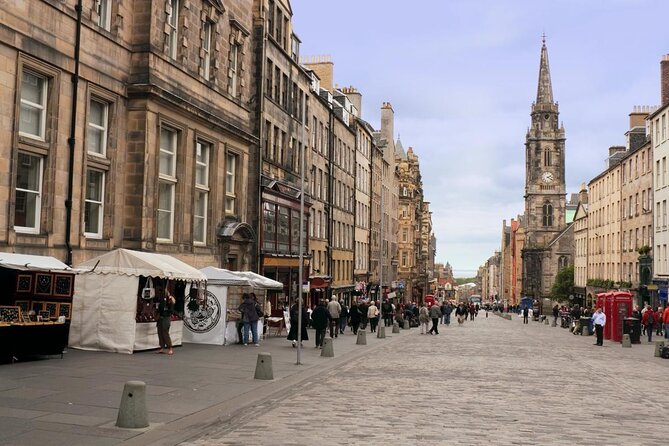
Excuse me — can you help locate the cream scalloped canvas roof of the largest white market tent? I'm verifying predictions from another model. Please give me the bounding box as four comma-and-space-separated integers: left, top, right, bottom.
77, 249, 207, 281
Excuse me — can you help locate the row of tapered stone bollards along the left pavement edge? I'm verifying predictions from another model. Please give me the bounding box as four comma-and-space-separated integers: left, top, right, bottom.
116, 321, 409, 429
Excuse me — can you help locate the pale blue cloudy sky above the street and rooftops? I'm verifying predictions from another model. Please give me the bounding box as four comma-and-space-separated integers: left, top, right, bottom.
291, 0, 669, 276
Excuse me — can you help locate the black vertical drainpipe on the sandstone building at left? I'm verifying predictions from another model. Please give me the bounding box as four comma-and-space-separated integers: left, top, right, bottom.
65, 0, 82, 266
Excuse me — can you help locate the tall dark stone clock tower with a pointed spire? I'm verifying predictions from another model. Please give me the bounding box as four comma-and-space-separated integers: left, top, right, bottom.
522, 37, 571, 298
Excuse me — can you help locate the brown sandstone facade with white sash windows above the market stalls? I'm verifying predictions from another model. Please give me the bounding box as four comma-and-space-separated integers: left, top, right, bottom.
0, 0, 257, 269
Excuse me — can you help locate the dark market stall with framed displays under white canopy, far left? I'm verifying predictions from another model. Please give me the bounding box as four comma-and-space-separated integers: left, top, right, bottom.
0, 253, 75, 361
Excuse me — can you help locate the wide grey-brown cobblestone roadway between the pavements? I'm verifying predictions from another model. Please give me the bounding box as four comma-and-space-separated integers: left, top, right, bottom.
182, 313, 669, 446
